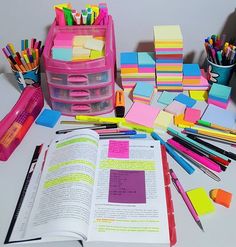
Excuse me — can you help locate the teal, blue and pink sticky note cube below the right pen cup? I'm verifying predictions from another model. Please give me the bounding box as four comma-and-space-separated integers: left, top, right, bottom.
208, 83, 231, 109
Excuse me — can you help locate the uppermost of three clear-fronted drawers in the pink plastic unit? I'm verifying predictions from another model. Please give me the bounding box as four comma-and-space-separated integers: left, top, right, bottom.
46, 70, 110, 86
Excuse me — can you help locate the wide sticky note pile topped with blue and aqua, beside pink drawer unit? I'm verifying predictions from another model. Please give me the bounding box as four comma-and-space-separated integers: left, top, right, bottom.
120, 52, 155, 90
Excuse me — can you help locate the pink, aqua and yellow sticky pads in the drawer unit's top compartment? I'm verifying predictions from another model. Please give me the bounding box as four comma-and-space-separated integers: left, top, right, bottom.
52, 32, 105, 61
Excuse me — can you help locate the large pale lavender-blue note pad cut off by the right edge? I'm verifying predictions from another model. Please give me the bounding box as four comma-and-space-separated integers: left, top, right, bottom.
201, 104, 236, 129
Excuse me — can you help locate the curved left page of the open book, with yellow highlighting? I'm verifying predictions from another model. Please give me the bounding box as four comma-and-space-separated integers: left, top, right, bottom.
26, 130, 99, 240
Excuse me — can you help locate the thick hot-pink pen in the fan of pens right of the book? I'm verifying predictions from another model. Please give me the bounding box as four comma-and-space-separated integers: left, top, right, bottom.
167, 139, 222, 172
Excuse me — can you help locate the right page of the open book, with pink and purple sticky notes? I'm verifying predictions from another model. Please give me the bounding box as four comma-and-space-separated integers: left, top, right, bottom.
84, 140, 170, 246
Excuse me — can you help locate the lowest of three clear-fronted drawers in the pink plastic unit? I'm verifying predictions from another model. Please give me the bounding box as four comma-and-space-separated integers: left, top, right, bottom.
51, 97, 114, 116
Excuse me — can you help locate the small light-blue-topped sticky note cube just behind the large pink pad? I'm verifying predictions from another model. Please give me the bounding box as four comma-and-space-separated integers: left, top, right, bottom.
133, 82, 154, 104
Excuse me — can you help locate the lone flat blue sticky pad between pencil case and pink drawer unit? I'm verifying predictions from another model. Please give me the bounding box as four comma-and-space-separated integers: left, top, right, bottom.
35, 109, 61, 128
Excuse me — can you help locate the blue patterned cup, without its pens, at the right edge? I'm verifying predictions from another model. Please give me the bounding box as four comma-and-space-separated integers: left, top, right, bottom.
207, 60, 235, 86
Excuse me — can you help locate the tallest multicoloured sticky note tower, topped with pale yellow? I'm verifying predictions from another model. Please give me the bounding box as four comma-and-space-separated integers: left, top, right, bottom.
154, 25, 183, 91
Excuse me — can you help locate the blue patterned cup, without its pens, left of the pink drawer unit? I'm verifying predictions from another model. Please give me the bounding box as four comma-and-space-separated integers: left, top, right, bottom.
12, 66, 41, 91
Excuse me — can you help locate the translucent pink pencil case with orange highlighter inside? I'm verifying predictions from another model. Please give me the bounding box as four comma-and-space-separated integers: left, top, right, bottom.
0, 86, 44, 161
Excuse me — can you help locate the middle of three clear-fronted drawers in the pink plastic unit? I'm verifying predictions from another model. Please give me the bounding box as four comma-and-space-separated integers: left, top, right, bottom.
48, 82, 114, 102
